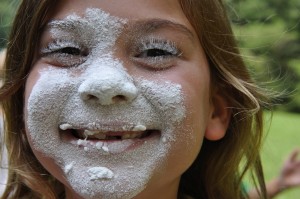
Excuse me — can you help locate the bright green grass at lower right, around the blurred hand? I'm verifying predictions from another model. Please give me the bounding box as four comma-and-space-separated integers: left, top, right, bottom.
262, 112, 300, 199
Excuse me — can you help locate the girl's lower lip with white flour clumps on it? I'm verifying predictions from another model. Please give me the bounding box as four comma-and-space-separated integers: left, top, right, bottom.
61, 132, 161, 155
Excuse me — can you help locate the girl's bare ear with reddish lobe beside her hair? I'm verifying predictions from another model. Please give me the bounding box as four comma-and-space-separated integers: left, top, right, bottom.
205, 93, 231, 141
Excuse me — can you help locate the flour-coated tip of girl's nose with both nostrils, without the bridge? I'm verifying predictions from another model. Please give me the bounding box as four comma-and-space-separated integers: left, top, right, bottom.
78, 73, 138, 105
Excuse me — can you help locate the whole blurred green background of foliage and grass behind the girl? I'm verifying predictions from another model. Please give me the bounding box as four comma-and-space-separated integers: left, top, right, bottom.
0, 0, 300, 199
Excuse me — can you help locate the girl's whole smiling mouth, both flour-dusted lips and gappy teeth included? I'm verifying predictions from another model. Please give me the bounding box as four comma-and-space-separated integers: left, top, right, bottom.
59, 123, 161, 152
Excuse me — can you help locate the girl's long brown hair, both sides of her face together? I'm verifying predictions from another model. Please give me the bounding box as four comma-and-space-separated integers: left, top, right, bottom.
0, 0, 267, 199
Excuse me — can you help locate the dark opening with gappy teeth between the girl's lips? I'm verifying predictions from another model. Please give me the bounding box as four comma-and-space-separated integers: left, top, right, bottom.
60, 124, 160, 141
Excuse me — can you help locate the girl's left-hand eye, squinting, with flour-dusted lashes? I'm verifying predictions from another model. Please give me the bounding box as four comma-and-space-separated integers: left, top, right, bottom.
41, 40, 88, 67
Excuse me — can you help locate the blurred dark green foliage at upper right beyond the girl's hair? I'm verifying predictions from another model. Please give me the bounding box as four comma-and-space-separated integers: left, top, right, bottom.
225, 0, 300, 113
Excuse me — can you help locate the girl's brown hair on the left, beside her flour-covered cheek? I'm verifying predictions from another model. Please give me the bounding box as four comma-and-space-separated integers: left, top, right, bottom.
0, 1, 61, 198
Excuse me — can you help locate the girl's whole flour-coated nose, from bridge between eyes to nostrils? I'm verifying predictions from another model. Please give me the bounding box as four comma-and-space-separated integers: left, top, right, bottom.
78, 54, 138, 105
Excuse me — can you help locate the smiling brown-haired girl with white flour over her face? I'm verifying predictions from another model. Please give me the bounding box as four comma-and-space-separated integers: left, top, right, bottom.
0, 0, 266, 199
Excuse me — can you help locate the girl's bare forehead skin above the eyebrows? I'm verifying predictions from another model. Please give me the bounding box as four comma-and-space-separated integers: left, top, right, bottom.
50, 0, 196, 35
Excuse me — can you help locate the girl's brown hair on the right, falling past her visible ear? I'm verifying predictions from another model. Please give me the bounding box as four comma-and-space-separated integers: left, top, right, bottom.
180, 0, 268, 199
